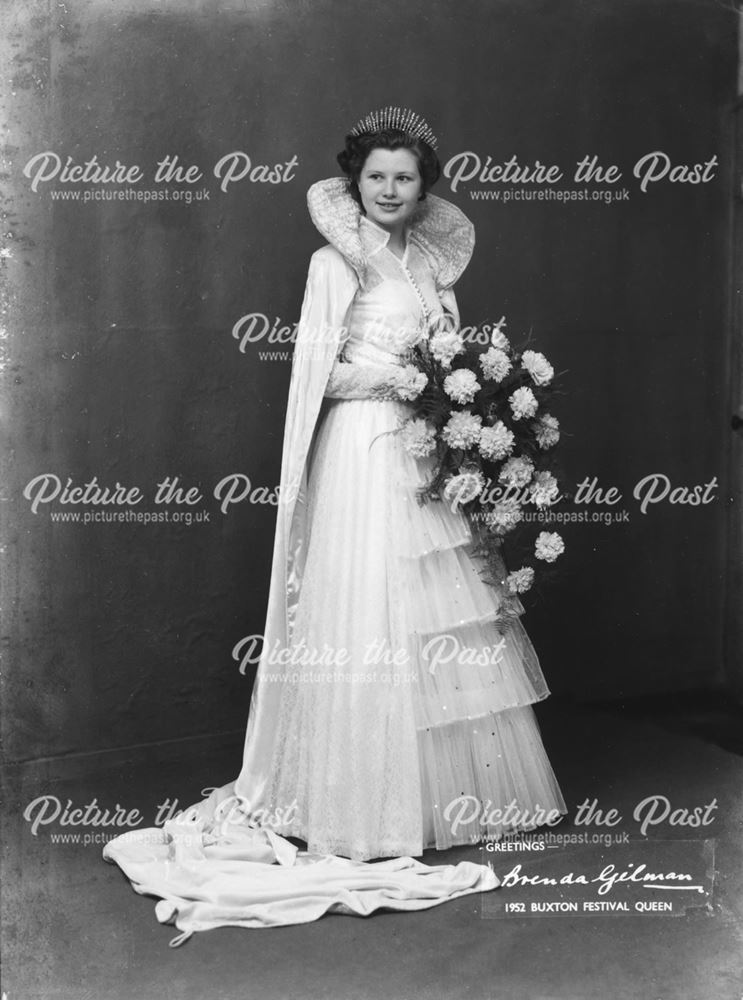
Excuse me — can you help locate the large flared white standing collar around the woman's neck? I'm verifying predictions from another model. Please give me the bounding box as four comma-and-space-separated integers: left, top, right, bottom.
307, 177, 475, 288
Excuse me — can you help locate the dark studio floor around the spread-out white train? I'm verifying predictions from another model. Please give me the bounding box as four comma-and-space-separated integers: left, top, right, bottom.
2, 698, 743, 1000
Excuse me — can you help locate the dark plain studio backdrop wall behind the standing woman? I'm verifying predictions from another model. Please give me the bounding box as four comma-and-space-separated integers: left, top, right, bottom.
3, 0, 737, 765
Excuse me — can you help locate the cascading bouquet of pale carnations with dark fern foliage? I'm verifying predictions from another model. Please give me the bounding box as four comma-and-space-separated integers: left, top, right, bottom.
400, 318, 565, 624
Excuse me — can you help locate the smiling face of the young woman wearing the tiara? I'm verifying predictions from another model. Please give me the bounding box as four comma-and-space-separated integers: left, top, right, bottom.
358, 149, 423, 231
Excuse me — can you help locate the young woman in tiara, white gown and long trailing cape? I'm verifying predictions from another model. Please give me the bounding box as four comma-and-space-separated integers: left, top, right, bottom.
105, 108, 566, 930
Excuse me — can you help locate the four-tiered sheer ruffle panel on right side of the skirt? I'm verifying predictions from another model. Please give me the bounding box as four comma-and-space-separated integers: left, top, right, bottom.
390, 402, 566, 849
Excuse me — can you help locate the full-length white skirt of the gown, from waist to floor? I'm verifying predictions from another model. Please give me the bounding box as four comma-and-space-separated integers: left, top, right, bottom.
258, 400, 566, 860
